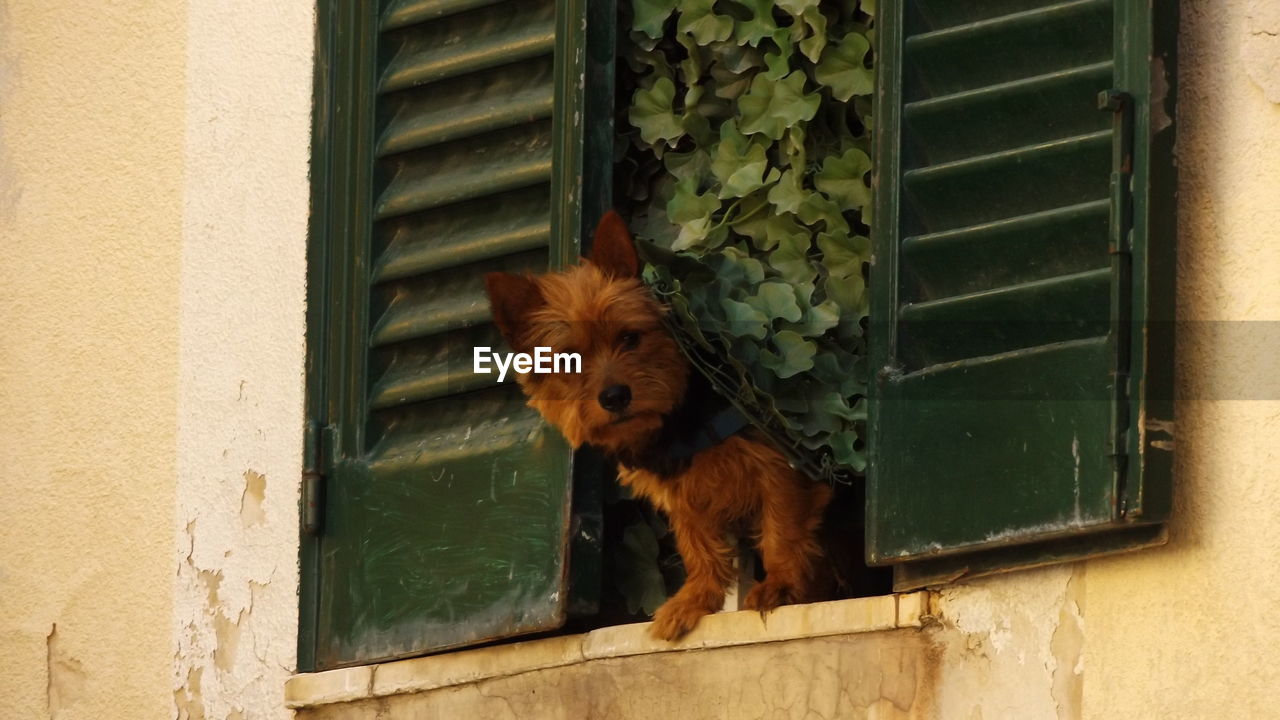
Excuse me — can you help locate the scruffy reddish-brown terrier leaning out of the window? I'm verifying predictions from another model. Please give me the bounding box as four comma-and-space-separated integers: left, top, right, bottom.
485, 211, 831, 639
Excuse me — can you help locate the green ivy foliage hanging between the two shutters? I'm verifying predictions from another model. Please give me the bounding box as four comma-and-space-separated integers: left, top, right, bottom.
617, 0, 876, 476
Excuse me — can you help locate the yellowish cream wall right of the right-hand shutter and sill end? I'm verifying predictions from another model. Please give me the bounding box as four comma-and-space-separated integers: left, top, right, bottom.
934, 0, 1280, 720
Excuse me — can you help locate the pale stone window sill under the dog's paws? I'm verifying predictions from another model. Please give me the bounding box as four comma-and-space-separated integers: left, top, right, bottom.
284, 592, 928, 708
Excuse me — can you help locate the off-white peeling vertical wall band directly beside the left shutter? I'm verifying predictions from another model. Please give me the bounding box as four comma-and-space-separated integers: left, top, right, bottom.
165, 0, 315, 720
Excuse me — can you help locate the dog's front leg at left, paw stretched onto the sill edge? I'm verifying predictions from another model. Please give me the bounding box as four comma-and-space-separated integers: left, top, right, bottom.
650, 514, 735, 641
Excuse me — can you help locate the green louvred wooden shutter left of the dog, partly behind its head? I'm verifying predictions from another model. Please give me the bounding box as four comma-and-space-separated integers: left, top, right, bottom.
300, 0, 612, 669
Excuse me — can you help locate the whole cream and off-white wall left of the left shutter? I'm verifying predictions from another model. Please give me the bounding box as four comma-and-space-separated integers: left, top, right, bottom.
0, 0, 315, 720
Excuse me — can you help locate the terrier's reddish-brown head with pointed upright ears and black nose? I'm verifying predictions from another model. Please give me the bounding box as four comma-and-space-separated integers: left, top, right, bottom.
485, 211, 689, 452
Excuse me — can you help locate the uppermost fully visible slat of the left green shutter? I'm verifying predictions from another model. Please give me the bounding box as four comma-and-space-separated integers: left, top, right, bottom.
379, 1, 556, 94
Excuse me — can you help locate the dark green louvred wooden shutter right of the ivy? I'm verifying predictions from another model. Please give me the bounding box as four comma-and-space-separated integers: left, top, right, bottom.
867, 0, 1178, 589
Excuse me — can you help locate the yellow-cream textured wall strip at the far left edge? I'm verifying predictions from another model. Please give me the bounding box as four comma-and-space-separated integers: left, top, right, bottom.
0, 0, 187, 720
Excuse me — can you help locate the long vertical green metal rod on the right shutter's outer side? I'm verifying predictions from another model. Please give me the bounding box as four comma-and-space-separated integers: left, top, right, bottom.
1098, 90, 1134, 504
